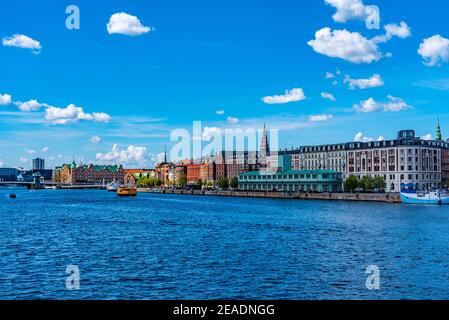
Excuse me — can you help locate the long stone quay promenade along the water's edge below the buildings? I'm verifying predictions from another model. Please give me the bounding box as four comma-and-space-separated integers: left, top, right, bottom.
139, 189, 401, 203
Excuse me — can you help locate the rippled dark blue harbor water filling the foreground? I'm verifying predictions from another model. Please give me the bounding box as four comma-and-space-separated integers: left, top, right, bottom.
0, 188, 449, 300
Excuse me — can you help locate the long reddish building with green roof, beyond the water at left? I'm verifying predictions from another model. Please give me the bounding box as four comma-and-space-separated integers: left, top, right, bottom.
58, 162, 125, 184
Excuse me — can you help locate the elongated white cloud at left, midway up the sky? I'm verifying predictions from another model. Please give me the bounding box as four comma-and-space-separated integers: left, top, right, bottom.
45, 104, 111, 124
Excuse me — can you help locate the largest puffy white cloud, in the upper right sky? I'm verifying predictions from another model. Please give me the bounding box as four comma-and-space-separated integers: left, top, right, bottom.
307, 28, 382, 64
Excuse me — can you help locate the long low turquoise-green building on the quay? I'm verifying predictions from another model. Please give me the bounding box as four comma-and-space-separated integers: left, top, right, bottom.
239, 170, 343, 193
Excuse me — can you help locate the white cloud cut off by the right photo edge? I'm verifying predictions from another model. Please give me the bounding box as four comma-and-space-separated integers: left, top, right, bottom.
418, 34, 449, 67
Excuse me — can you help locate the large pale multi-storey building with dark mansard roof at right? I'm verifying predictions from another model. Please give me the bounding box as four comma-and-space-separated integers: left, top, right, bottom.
298, 130, 449, 192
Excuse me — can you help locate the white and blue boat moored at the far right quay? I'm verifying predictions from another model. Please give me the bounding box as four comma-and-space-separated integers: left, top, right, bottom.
401, 184, 449, 205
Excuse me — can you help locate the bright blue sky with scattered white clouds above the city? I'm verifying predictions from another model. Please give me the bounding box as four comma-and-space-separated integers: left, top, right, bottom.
0, 0, 449, 167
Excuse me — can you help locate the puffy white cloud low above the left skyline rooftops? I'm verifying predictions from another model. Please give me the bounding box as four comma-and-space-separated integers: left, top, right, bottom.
96, 144, 147, 164
